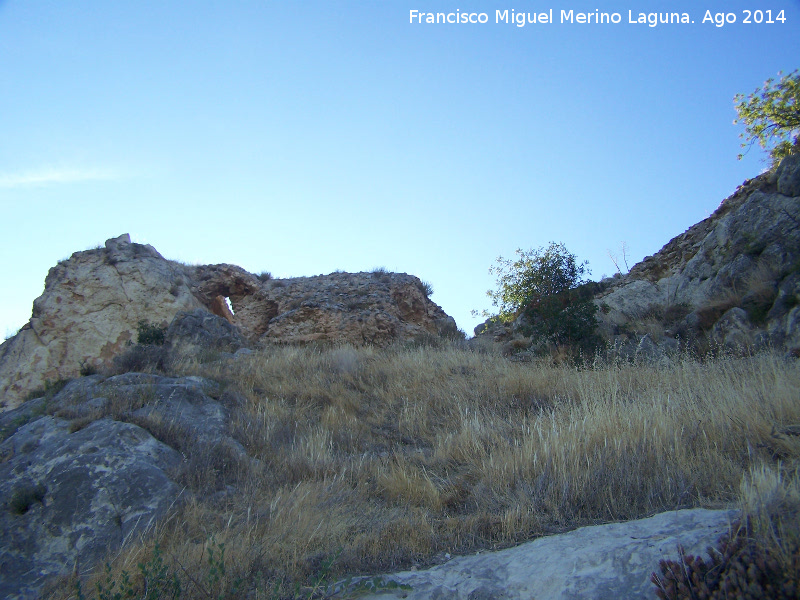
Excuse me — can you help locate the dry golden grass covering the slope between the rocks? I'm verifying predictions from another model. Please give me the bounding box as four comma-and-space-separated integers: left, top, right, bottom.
48, 347, 800, 597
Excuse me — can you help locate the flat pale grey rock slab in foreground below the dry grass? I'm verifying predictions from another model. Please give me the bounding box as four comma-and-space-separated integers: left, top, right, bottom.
363, 509, 738, 600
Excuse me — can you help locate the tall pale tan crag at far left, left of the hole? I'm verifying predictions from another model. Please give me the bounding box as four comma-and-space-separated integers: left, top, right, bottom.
0, 235, 202, 408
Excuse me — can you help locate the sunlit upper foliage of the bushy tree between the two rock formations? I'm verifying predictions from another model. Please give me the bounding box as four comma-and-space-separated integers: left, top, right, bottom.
486, 242, 588, 323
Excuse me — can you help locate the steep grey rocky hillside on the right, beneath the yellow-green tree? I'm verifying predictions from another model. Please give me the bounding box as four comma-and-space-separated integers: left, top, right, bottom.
476, 155, 800, 360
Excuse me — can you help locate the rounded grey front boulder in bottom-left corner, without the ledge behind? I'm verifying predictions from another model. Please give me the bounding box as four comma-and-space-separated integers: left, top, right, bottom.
0, 416, 181, 598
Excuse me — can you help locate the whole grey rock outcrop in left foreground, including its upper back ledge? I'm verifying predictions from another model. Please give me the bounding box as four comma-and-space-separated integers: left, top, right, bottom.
0, 373, 251, 598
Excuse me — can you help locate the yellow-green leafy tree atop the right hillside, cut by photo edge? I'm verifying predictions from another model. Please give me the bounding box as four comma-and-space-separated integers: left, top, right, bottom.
733, 69, 800, 167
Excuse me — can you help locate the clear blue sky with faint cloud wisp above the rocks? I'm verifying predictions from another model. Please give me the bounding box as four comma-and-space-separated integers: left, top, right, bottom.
0, 0, 800, 335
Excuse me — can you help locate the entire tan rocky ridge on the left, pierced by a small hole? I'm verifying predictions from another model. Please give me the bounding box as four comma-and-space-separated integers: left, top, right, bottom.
0, 234, 458, 410
